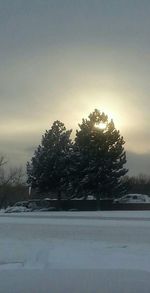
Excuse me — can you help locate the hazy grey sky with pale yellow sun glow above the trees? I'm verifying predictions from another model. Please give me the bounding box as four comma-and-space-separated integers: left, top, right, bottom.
0, 0, 150, 175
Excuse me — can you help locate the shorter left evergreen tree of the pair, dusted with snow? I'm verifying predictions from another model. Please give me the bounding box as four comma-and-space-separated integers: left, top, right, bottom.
27, 121, 72, 200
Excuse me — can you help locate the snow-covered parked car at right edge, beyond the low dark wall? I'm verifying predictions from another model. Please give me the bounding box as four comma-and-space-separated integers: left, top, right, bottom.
114, 193, 150, 203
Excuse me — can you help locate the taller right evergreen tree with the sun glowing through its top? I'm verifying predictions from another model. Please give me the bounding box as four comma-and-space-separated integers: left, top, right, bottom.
75, 110, 127, 204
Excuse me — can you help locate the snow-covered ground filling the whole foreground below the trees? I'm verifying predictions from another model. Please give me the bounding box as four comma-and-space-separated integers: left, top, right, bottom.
0, 211, 150, 293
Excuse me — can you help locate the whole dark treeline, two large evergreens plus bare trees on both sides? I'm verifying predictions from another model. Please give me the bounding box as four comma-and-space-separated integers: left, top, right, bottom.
0, 110, 150, 208
